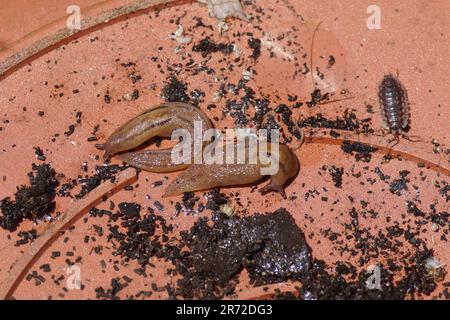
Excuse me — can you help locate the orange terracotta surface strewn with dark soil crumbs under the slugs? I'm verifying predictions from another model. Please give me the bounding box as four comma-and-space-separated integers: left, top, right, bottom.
0, 1, 450, 299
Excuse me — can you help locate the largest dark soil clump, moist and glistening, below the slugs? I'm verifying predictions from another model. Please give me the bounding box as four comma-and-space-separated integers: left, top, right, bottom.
178, 209, 311, 298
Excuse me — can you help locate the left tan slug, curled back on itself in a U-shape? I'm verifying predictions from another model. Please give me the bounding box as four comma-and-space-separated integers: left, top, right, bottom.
98, 102, 212, 172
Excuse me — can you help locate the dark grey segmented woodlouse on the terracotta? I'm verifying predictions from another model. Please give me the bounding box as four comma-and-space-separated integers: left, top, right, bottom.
378, 74, 410, 136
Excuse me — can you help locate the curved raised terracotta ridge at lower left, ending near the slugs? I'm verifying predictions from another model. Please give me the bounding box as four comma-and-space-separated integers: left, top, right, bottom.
0, 168, 137, 300
